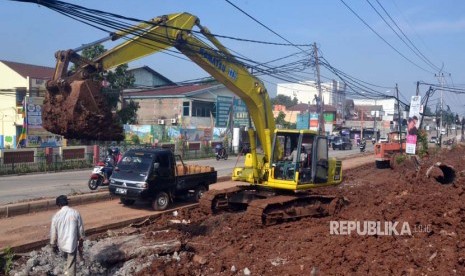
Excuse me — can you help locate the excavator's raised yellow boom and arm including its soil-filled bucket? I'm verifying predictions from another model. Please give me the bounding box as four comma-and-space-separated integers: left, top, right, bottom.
43, 13, 275, 170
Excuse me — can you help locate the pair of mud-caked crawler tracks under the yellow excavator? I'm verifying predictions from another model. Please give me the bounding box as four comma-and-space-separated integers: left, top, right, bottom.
199, 186, 348, 225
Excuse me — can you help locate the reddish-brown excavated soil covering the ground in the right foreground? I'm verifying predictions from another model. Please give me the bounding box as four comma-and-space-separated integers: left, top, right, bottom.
8, 146, 465, 275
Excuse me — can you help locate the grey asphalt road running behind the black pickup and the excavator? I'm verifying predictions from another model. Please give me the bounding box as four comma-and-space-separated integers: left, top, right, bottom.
0, 146, 373, 205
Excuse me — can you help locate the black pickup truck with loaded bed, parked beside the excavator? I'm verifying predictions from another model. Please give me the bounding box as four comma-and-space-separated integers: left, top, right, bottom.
109, 149, 217, 211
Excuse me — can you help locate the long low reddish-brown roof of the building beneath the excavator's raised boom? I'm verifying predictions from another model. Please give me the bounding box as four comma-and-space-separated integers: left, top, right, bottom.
124, 84, 222, 98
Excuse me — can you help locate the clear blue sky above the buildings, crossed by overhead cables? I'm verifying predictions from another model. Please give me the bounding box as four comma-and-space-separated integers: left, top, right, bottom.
0, 0, 465, 116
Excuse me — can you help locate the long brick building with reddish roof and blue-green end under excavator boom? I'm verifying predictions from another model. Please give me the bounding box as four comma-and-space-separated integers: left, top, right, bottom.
124, 82, 248, 128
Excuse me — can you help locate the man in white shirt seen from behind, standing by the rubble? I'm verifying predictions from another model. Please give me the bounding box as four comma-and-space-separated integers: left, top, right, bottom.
50, 195, 85, 276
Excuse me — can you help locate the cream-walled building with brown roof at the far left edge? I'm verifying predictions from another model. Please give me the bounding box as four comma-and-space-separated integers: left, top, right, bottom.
0, 60, 55, 148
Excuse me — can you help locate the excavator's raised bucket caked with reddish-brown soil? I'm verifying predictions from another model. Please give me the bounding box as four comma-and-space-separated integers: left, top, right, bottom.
42, 79, 124, 141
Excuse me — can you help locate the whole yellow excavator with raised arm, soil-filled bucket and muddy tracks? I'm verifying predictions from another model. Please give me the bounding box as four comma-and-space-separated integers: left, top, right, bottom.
42, 13, 343, 224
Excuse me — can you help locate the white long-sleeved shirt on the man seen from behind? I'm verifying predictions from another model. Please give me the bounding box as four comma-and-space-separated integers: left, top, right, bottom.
50, 206, 84, 253
